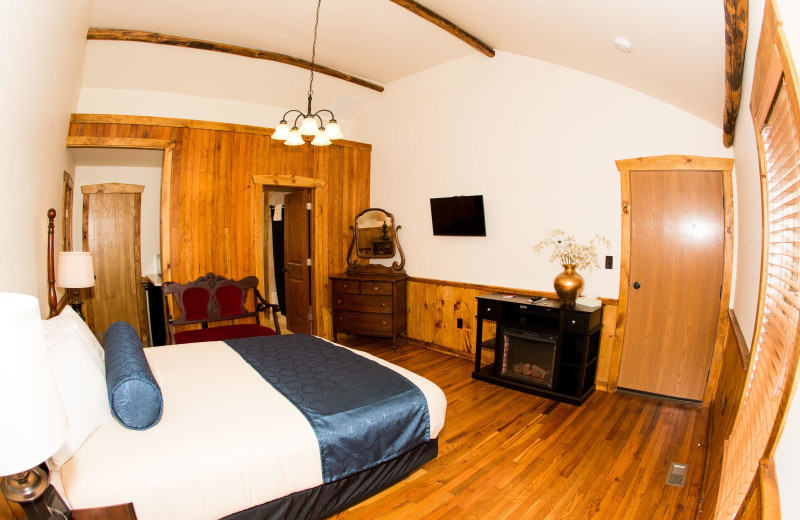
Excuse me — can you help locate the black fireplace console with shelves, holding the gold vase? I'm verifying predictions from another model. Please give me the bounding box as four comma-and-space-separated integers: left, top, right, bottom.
472, 293, 603, 405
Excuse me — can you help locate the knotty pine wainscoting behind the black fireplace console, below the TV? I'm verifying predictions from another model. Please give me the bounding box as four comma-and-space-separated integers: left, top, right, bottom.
406, 278, 619, 390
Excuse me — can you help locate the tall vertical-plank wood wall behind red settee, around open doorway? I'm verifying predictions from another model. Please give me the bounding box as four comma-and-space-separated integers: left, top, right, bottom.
68, 114, 372, 337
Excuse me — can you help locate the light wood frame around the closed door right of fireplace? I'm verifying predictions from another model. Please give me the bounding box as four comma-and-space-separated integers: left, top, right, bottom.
608, 155, 734, 407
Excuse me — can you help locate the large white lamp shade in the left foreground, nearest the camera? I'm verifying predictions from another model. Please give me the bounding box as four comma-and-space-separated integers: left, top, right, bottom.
0, 293, 69, 476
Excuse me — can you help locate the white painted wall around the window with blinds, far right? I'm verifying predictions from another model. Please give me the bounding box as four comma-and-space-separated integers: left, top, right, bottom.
732, 0, 800, 518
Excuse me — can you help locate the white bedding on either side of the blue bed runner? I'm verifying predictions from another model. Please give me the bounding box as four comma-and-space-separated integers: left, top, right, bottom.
52, 341, 447, 520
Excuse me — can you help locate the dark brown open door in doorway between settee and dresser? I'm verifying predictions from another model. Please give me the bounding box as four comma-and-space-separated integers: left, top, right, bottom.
283, 190, 311, 334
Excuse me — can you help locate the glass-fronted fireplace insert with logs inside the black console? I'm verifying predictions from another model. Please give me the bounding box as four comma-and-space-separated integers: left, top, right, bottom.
495, 328, 558, 389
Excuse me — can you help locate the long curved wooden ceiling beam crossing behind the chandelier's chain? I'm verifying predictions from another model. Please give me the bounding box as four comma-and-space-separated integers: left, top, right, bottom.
86, 28, 383, 92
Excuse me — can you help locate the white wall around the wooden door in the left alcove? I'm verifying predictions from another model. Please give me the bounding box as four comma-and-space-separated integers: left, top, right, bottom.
72, 166, 161, 275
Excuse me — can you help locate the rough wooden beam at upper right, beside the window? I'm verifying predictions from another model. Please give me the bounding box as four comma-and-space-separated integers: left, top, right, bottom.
722, 0, 749, 148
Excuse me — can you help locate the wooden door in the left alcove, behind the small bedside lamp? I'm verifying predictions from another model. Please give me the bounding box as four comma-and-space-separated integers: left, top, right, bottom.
81, 183, 149, 345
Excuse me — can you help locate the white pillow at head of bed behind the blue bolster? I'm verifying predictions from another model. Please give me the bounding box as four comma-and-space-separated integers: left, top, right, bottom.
42, 307, 111, 470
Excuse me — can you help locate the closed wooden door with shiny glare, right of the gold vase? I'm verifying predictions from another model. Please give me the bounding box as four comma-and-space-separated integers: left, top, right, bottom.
618, 170, 725, 401
